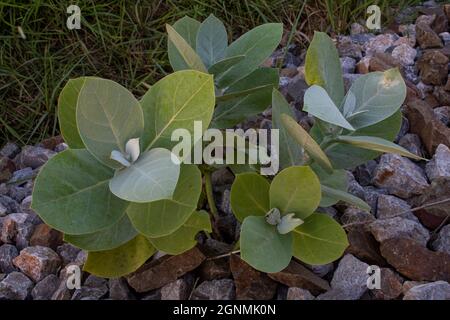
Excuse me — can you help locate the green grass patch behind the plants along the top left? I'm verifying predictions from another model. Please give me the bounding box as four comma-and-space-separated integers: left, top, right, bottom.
0, 0, 417, 146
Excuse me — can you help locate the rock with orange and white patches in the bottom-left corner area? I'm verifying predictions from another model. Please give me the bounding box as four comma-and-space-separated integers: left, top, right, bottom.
13, 246, 61, 282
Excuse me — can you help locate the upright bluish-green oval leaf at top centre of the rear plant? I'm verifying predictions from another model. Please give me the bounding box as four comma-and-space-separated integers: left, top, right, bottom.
197, 14, 228, 68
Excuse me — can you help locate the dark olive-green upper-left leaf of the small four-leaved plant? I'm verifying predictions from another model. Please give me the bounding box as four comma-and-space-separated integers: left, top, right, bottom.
230, 173, 270, 222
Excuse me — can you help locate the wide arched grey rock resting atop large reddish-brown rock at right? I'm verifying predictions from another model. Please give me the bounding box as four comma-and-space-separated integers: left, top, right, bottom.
369, 217, 430, 246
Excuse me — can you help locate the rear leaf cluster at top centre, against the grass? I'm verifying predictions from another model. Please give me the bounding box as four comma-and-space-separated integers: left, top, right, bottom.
166, 15, 283, 129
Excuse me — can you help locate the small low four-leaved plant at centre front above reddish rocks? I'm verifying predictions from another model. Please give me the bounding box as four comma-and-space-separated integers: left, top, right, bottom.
231, 166, 348, 273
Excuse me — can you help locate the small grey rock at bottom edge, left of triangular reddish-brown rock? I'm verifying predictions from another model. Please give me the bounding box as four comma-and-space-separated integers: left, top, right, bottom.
192, 279, 236, 300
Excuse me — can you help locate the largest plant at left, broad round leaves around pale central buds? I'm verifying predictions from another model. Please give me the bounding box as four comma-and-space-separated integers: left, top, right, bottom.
32, 70, 215, 277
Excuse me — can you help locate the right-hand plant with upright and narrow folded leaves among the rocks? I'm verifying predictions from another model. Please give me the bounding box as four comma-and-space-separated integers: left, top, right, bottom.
272, 32, 421, 210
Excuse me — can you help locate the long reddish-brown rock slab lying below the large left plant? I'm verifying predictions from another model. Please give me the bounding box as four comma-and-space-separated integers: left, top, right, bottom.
127, 247, 206, 292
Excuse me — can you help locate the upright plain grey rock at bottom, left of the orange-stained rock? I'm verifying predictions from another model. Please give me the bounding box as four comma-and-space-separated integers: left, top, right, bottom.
331, 254, 369, 300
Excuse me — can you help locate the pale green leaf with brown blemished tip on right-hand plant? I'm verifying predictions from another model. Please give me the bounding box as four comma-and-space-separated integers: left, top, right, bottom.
343, 69, 406, 129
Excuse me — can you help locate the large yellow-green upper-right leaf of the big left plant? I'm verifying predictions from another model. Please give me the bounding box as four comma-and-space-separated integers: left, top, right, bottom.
141, 70, 215, 150
